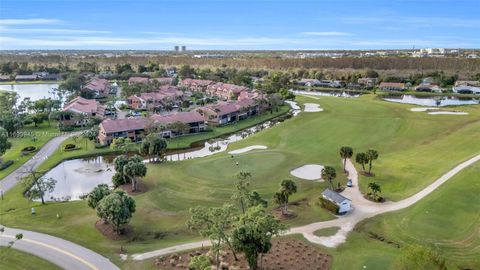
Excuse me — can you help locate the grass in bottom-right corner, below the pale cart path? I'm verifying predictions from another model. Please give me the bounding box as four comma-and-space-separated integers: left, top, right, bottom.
328, 162, 480, 269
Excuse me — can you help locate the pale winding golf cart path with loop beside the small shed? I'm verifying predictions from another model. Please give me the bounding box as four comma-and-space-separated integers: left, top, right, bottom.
132, 154, 480, 260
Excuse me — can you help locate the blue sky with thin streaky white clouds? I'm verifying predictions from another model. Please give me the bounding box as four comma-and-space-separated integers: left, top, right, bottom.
0, 0, 480, 50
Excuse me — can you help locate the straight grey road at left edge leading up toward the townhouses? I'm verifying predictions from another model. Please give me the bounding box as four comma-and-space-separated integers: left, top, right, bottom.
0, 132, 80, 192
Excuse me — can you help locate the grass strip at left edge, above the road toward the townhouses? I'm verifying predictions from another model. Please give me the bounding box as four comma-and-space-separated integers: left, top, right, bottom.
0, 122, 59, 179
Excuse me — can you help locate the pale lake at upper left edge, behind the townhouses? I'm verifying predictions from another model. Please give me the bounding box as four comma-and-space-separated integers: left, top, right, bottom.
0, 83, 58, 103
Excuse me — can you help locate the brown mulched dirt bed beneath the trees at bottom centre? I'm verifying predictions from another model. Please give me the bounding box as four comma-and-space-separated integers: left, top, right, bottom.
155, 237, 332, 270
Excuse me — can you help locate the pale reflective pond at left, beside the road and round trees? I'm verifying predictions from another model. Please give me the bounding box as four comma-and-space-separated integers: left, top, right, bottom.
37, 156, 115, 201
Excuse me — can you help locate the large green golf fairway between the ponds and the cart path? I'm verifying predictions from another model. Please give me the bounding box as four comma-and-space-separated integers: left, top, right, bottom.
0, 95, 480, 269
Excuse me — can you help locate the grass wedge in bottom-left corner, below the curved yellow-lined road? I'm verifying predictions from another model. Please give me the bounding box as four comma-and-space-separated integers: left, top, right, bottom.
0, 247, 61, 270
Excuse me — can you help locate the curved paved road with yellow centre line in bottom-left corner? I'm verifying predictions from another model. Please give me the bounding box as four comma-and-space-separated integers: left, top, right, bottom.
0, 228, 119, 270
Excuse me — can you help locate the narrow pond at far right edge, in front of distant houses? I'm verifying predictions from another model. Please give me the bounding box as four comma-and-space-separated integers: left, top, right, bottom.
384, 95, 480, 107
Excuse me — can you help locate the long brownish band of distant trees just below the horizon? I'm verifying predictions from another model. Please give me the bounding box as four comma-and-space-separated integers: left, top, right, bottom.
0, 54, 480, 76
